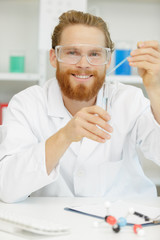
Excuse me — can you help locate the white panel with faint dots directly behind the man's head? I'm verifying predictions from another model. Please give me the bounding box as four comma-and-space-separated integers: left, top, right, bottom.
39, 0, 87, 50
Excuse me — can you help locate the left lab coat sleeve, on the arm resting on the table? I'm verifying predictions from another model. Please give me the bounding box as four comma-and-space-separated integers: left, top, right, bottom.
0, 94, 59, 203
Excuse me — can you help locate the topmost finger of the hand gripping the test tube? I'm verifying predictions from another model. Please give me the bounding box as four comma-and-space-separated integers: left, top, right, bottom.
82, 105, 111, 121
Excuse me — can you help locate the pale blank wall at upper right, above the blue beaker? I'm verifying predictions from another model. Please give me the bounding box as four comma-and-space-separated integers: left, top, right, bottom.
88, 0, 160, 42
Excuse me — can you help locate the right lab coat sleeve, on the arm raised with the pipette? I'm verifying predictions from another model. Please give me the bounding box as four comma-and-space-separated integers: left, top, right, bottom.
133, 91, 160, 165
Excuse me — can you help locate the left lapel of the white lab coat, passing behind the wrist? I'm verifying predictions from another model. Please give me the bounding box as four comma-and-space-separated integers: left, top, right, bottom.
47, 79, 79, 155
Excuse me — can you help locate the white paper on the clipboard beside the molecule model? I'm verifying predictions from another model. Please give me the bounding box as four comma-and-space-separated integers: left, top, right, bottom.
68, 201, 160, 224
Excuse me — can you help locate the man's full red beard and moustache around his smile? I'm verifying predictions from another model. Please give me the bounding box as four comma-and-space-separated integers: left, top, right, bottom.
56, 64, 106, 101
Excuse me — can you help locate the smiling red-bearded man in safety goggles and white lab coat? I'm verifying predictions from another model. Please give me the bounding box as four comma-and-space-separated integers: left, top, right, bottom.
0, 11, 160, 202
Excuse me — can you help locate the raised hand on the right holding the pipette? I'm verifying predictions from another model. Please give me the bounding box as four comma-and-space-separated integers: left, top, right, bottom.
128, 41, 160, 88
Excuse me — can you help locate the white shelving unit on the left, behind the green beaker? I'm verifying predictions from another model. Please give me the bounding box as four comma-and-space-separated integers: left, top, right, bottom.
0, 0, 40, 102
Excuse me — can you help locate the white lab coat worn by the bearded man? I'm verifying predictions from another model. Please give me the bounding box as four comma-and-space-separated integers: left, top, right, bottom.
0, 79, 160, 202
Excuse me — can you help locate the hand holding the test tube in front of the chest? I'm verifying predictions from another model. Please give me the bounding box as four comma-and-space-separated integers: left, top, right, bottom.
63, 106, 113, 143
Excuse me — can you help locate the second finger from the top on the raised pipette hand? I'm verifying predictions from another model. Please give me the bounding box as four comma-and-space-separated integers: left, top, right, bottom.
130, 48, 160, 59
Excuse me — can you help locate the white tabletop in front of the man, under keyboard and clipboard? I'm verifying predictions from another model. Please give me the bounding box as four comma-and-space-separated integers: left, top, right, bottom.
0, 197, 160, 240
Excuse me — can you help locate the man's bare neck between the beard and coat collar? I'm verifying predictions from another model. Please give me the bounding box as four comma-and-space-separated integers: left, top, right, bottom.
62, 95, 97, 116
